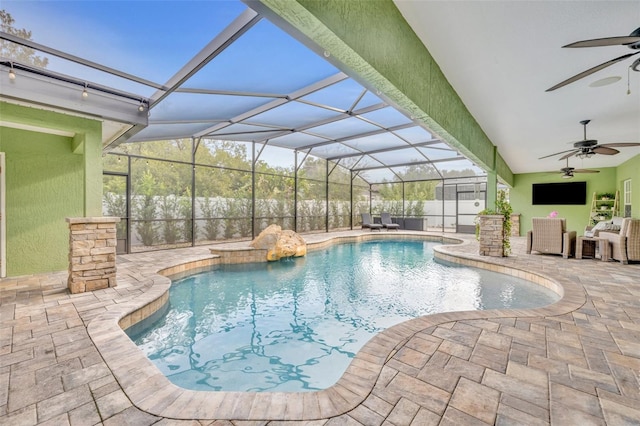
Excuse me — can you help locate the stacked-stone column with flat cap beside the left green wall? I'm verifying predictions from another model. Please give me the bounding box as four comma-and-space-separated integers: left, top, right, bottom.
67, 217, 120, 293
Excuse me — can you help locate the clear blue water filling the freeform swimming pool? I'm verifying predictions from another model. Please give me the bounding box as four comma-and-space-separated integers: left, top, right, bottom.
128, 241, 559, 391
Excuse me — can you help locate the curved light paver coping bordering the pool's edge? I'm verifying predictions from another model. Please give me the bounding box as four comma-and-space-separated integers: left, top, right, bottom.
87, 232, 586, 421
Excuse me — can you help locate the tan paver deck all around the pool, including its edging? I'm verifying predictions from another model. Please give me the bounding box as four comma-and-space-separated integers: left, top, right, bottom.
0, 231, 640, 426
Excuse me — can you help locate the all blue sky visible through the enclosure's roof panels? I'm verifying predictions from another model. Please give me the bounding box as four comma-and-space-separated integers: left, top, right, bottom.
1, 0, 484, 181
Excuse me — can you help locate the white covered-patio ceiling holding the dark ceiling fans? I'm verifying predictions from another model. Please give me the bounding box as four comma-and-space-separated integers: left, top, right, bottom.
394, 0, 640, 173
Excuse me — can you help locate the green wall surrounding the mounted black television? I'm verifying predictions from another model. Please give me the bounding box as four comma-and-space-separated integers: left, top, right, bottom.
509, 167, 616, 235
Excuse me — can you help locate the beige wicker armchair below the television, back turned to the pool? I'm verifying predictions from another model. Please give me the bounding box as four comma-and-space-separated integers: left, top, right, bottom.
527, 217, 576, 259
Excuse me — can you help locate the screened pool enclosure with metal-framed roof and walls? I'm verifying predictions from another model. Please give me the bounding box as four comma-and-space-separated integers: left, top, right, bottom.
0, 1, 486, 252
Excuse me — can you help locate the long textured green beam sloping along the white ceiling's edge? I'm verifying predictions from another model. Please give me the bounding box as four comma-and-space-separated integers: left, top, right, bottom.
252, 0, 513, 185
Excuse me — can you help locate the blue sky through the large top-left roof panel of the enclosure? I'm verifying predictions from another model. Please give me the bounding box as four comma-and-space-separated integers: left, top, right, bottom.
2, 0, 246, 83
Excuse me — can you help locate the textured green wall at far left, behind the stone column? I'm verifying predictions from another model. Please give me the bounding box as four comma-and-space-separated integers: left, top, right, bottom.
0, 102, 102, 276
